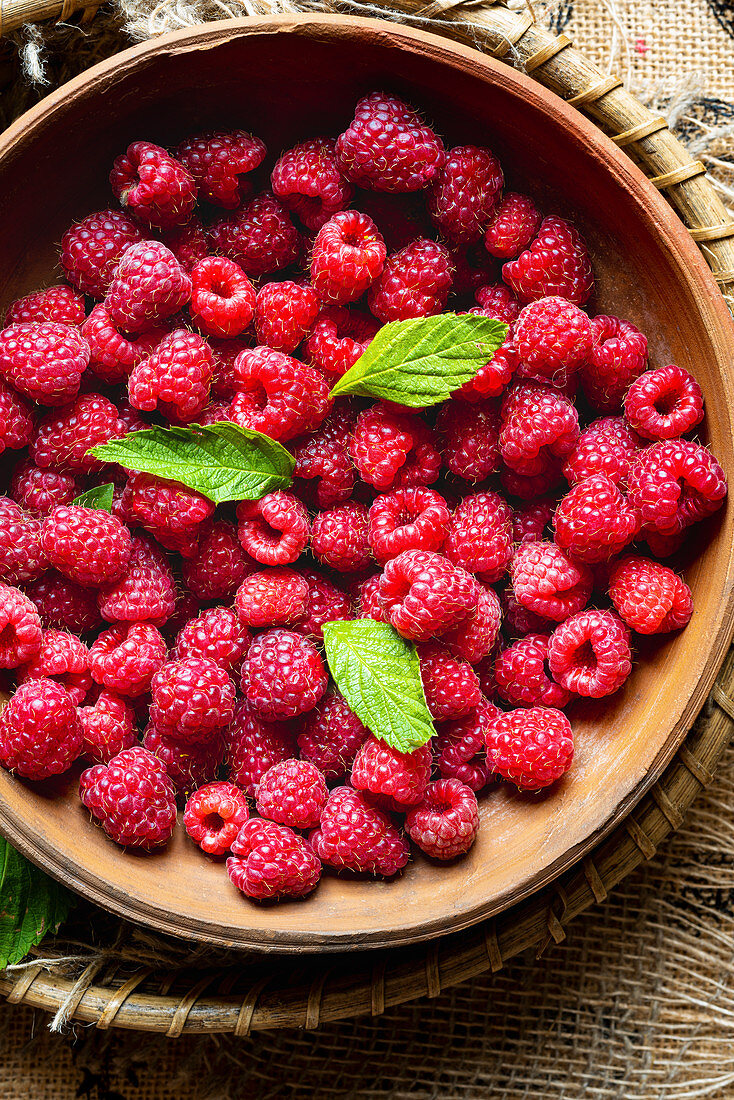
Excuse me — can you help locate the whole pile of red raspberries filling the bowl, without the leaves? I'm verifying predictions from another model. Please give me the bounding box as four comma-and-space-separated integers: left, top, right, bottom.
0, 92, 726, 899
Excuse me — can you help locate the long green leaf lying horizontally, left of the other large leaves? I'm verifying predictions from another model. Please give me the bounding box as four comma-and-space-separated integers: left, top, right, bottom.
88, 421, 295, 504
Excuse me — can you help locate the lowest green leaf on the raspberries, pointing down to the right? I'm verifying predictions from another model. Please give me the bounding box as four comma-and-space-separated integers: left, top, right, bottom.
324, 619, 436, 752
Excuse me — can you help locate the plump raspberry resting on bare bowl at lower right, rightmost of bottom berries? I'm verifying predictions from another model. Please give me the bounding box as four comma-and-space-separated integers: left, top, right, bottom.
484, 706, 573, 791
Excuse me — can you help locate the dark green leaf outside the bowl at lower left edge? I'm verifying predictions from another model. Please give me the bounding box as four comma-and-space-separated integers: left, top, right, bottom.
0, 836, 75, 969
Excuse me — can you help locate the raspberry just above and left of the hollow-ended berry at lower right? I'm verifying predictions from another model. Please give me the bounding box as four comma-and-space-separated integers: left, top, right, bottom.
510, 542, 593, 623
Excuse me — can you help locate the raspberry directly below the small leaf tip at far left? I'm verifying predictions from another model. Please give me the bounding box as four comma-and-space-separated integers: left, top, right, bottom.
41, 505, 132, 587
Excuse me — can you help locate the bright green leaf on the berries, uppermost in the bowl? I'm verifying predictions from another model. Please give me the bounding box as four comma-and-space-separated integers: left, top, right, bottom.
331, 314, 508, 408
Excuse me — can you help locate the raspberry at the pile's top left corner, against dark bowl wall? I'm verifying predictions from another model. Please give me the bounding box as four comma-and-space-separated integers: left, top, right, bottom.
110, 141, 196, 229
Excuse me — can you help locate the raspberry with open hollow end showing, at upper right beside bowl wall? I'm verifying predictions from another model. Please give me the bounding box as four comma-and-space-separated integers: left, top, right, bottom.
624, 363, 703, 439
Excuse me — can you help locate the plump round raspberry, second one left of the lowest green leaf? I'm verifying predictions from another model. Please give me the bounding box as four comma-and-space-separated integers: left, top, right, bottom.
151, 657, 234, 745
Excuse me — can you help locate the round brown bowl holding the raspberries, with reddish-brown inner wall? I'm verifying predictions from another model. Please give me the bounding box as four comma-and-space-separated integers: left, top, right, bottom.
0, 17, 734, 952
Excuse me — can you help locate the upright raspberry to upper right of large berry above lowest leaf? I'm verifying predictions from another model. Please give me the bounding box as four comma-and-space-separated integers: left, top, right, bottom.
443, 493, 513, 583
